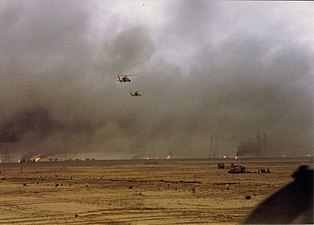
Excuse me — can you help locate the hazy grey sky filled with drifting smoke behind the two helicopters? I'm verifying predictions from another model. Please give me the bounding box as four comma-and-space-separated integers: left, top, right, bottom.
0, 0, 314, 159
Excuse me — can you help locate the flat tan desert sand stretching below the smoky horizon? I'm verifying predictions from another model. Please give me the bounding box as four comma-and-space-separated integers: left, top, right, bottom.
0, 159, 313, 225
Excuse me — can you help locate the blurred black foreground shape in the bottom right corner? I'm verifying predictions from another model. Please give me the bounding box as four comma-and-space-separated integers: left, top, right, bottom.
242, 165, 314, 224
